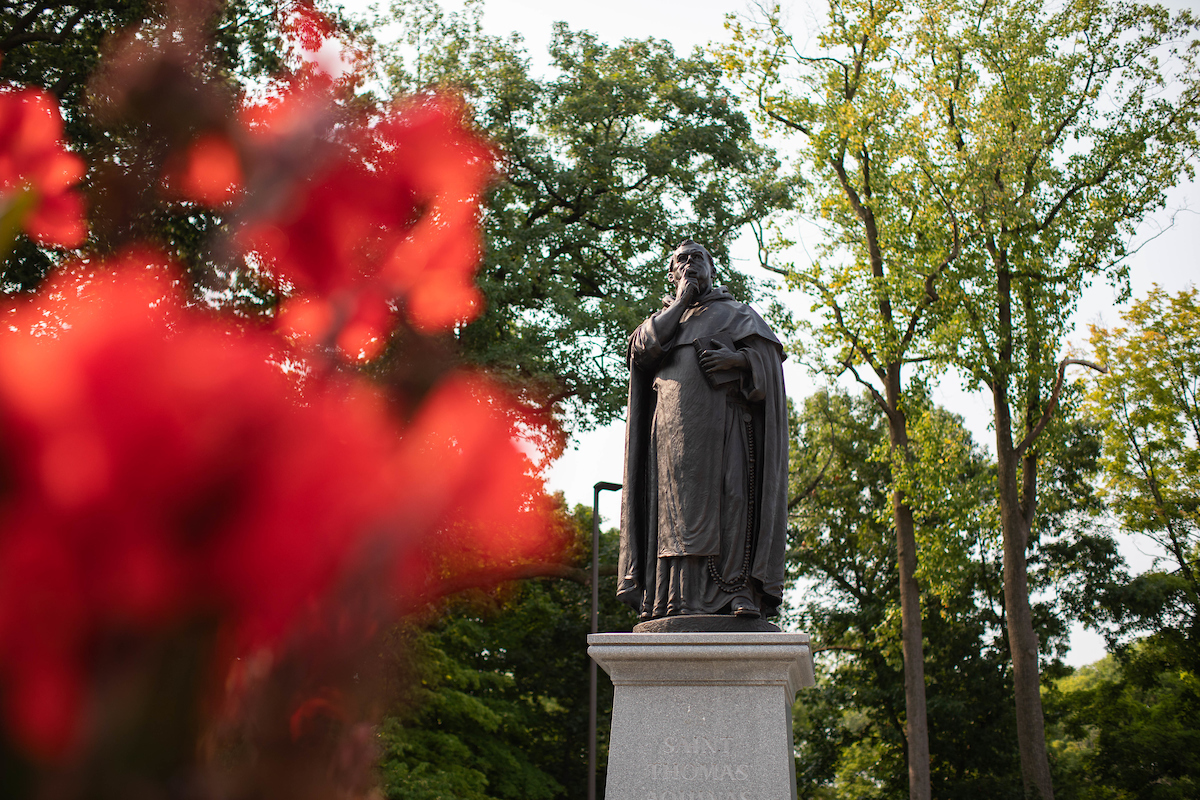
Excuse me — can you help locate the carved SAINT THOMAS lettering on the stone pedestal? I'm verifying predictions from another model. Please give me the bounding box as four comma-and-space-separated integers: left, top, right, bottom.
646, 736, 757, 800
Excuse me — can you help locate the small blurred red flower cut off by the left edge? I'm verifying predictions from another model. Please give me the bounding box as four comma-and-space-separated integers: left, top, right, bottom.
0, 89, 88, 247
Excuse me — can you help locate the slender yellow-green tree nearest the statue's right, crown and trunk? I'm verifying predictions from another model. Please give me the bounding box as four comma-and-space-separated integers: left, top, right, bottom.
721, 0, 959, 800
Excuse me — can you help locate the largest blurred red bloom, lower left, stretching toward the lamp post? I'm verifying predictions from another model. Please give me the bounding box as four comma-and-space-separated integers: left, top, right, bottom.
0, 253, 552, 757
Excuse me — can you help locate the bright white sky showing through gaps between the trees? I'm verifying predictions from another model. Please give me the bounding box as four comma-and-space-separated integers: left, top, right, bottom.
347, 0, 1200, 664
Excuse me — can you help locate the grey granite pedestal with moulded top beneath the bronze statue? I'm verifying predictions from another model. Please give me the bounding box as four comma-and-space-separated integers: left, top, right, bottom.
588, 633, 814, 800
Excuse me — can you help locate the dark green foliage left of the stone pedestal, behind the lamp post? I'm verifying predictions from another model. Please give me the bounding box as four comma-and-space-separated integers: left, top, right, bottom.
379, 506, 636, 800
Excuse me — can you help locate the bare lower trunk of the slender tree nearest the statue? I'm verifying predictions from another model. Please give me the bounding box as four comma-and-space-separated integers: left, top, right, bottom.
887, 365, 930, 800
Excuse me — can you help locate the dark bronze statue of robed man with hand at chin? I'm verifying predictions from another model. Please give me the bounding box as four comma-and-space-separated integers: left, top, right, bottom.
617, 239, 787, 621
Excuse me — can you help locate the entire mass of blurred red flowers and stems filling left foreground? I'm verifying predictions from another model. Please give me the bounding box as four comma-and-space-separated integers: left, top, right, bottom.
0, 0, 565, 796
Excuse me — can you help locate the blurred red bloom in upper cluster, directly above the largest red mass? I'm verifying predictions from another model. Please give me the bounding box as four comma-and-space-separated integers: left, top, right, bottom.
245, 94, 494, 345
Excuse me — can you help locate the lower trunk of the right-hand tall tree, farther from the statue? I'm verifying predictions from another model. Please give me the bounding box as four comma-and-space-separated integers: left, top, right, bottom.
995, 392, 1054, 800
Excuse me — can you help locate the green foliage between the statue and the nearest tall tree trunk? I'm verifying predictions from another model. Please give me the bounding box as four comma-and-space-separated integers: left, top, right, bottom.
787, 392, 905, 798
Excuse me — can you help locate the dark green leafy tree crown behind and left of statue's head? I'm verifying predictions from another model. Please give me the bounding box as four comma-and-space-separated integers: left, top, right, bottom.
369, 2, 791, 427
